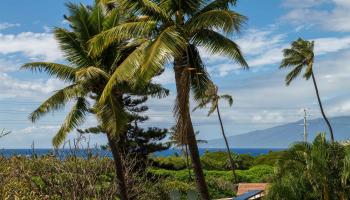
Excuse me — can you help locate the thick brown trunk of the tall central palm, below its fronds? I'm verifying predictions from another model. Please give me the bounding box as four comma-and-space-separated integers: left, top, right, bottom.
174, 65, 210, 200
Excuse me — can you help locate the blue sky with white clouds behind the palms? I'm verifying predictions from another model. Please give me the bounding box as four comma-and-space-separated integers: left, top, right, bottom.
0, 0, 350, 148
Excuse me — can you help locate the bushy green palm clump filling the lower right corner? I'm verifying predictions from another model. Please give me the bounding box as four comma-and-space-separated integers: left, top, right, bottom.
267, 134, 350, 200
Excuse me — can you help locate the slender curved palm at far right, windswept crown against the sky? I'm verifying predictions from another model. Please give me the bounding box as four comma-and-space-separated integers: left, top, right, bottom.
280, 38, 334, 142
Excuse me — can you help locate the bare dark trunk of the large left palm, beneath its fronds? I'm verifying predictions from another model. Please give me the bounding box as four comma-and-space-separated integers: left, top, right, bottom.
107, 134, 129, 200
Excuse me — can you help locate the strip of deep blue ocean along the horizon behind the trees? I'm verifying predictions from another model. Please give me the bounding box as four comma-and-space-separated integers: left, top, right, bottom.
0, 148, 283, 158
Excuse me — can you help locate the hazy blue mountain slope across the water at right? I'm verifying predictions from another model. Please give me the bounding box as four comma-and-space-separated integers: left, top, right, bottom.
200, 116, 350, 148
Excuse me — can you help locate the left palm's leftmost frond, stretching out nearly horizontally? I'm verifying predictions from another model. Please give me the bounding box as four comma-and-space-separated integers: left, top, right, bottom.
21, 62, 77, 82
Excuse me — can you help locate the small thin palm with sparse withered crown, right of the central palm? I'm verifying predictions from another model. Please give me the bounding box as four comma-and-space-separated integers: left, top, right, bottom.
193, 84, 238, 183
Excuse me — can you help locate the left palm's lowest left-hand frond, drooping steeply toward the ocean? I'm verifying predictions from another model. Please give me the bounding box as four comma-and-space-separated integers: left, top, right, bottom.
52, 97, 89, 148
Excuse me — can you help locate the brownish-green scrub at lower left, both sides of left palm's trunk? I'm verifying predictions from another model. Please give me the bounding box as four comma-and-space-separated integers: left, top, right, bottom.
0, 156, 168, 200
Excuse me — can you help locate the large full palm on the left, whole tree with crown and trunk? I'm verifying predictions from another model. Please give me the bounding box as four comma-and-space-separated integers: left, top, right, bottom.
22, 1, 164, 200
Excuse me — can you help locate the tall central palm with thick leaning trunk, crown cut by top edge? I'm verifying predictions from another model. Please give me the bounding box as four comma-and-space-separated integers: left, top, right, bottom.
90, 0, 248, 200
